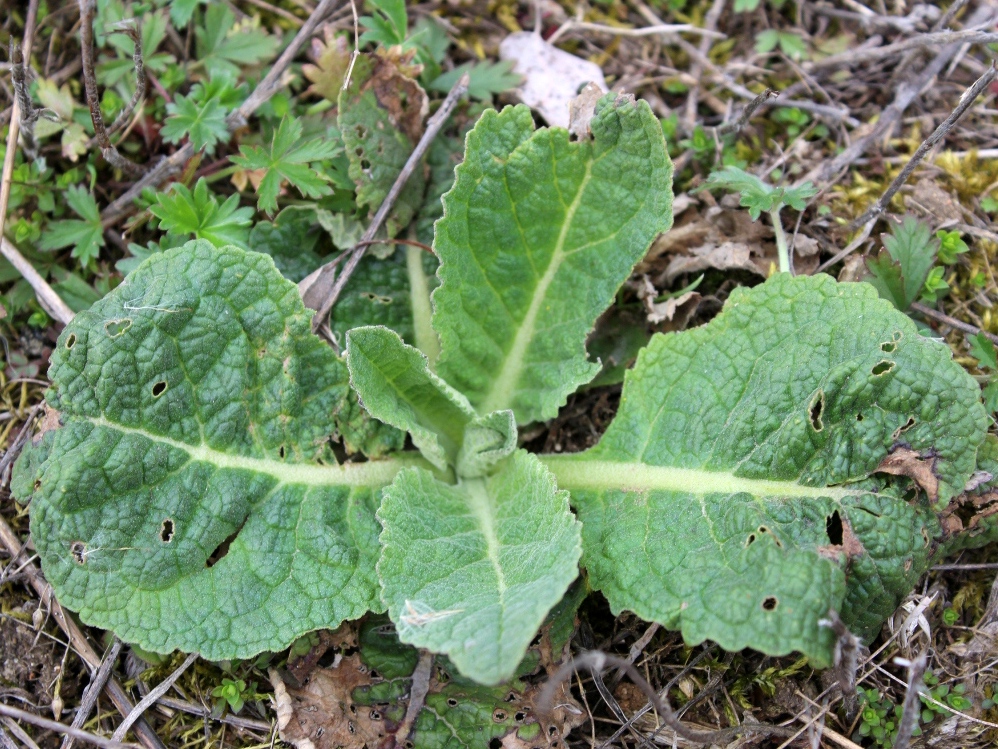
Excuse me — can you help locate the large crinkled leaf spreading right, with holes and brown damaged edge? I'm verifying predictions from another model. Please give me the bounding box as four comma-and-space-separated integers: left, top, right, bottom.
545, 274, 987, 664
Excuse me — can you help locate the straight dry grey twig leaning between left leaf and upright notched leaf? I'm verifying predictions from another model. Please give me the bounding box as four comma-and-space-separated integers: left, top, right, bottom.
299, 73, 471, 331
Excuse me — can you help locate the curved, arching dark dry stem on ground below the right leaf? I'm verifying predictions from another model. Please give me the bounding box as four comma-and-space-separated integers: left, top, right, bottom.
537, 650, 794, 745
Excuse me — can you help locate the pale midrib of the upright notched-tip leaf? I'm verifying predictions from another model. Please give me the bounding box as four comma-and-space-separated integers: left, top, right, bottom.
481, 159, 593, 413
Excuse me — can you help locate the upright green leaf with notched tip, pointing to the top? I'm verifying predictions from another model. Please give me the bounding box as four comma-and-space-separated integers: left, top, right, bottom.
433, 95, 672, 424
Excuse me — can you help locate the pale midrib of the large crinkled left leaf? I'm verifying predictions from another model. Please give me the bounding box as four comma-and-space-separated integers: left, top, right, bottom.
84, 416, 414, 488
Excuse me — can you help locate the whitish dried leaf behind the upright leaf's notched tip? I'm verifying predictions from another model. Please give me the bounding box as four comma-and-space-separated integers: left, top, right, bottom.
499, 31, 608, 132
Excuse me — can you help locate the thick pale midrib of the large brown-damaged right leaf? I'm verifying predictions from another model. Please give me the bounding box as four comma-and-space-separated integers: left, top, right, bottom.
537, 455, 868, 500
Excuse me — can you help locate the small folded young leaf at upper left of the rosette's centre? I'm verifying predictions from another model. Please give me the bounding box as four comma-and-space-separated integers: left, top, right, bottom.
347, 326, 476, 470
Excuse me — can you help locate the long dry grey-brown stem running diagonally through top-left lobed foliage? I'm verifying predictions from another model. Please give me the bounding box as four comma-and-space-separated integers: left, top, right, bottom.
101, 0, 337, 228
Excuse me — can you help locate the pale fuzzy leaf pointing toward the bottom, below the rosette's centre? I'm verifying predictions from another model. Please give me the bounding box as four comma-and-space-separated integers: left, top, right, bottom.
378, 450, 581, 684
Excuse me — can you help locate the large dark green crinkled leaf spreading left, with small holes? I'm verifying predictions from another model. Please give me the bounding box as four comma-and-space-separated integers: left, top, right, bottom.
14, 241, 414, 660
